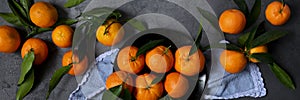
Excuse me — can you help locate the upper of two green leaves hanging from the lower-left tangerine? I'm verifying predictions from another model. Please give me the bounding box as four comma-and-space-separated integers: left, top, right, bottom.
18, 50, 35, 85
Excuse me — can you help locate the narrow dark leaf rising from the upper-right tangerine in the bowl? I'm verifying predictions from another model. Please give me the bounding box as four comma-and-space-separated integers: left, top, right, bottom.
189, 24, 202, 56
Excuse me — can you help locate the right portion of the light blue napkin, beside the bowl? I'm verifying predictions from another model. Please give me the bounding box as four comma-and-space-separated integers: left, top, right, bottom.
204, 49, 266, 99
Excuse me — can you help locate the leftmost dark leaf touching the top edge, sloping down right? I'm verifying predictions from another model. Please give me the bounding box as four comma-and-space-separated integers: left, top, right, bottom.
7, 0, 30, 26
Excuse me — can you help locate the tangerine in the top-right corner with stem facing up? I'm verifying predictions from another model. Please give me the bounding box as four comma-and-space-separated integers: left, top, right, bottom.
265, 1, 291, 26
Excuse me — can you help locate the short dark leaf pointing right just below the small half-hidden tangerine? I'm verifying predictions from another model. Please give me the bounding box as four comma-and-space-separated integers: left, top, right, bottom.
250, 53, 274, 64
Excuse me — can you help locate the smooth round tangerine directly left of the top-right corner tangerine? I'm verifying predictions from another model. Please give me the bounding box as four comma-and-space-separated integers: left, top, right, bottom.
219, 9, 246, 34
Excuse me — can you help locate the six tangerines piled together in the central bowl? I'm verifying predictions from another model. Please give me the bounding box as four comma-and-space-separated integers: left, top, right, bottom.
106, 45, 205, 100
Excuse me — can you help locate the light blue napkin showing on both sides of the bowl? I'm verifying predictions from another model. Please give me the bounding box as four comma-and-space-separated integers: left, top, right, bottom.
69, 49, 266, 100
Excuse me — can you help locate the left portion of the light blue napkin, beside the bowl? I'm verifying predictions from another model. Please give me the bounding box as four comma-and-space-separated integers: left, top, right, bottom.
69, 49, 119, 100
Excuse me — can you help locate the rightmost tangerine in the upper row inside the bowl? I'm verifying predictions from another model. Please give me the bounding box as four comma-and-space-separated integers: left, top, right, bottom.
175, 46, 205, 76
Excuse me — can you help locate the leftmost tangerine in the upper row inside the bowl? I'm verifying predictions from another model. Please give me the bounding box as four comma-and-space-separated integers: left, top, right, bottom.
117, 46, 145, 74
